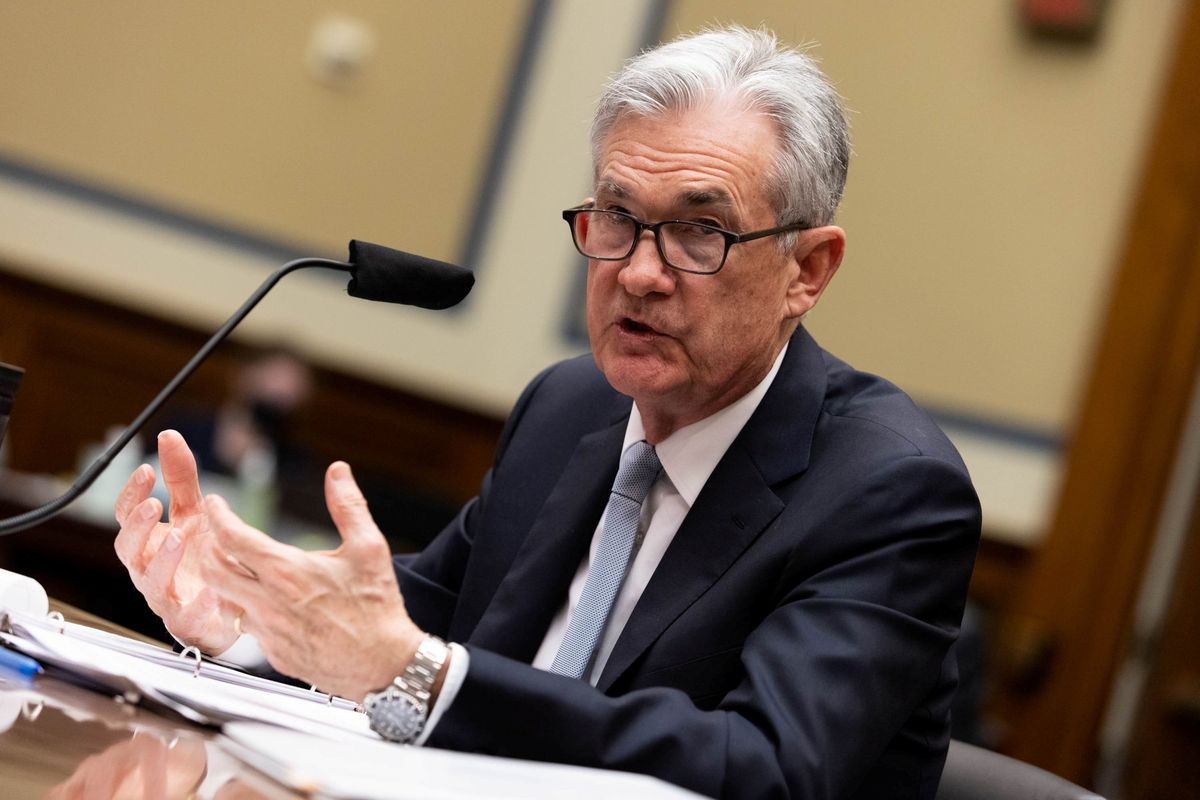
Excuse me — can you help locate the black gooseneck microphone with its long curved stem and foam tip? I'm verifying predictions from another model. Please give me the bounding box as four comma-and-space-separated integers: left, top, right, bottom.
0, 240, 475, 536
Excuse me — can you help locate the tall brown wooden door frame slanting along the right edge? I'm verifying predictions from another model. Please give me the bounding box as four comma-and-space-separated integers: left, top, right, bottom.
1001, 2, 1200, 783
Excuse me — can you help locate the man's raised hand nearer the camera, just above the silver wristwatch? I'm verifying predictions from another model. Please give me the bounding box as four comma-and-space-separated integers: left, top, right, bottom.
204, 462, 425, 700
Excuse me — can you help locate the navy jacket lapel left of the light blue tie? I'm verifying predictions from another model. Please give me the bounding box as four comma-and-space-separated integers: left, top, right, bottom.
469, 414, 628, 661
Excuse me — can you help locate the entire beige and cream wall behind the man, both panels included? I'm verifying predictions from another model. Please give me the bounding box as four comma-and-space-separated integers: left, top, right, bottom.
0, 0, 1180, 433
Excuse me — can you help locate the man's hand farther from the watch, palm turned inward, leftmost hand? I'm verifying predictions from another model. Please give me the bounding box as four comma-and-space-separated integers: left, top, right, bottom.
114, 431, 241, 654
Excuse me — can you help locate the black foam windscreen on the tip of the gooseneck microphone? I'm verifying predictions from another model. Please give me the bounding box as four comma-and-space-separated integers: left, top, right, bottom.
346, 240, 475, 309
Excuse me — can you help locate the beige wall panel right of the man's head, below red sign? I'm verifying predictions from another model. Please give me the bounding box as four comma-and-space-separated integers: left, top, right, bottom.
668, 0, 1180, 434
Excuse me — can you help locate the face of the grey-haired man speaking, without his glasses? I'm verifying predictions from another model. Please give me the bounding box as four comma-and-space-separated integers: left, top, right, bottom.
588, 104, 808, 433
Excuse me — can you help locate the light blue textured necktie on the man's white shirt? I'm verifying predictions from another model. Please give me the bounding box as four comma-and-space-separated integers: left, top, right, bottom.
550, 440, 662, 678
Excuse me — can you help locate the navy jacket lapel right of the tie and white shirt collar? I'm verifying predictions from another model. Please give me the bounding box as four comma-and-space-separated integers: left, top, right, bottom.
598, 327, 827, 690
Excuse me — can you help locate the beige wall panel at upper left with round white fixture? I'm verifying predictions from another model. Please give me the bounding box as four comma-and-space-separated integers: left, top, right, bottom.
0, 0, 527, 258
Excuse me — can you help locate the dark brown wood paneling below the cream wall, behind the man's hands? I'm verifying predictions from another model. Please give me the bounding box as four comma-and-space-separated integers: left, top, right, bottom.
0, 271, 502, 522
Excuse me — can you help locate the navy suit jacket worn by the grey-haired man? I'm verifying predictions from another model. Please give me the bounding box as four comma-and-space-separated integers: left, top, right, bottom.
396, 327, 979, 800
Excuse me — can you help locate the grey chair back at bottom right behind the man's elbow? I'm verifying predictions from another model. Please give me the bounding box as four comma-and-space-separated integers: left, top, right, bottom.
936, 740, 1104, 800
